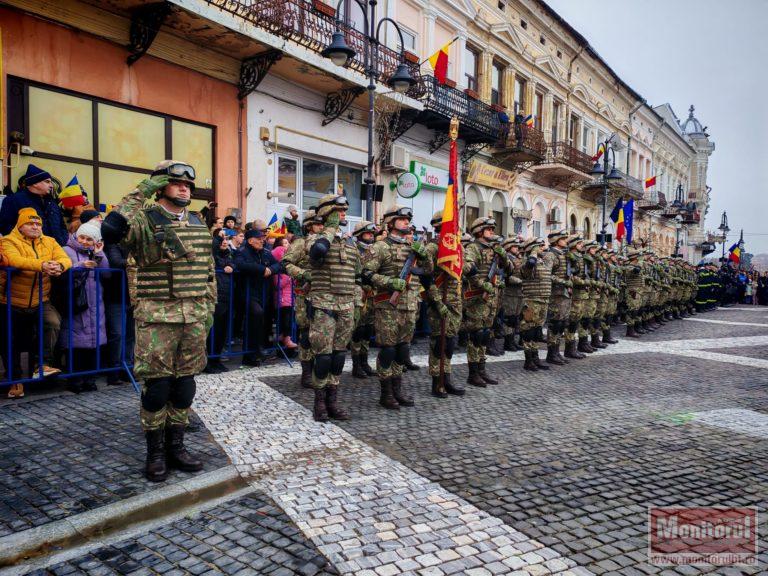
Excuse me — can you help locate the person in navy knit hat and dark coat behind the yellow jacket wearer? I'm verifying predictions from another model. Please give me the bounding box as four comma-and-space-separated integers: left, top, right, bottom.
0, 164, 69, 246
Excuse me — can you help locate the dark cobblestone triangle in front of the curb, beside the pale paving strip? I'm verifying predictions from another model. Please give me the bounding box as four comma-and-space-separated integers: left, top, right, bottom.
30, 494, 338, 576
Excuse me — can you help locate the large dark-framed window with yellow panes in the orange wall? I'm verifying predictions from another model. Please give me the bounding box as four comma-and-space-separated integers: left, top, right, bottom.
8, 77, 216, 209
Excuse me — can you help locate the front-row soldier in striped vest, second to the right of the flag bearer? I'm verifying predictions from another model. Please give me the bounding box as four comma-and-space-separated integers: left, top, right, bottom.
520, 238, 555, 372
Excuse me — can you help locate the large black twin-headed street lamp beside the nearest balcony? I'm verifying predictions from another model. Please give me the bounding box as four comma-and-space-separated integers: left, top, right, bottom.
321, 0, 416, 218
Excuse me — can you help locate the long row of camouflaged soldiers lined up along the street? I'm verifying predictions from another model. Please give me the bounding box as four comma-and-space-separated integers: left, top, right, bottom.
283, 194, 696, 421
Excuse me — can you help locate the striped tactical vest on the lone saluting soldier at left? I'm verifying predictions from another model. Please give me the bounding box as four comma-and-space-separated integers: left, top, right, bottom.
136, 207, 212, 300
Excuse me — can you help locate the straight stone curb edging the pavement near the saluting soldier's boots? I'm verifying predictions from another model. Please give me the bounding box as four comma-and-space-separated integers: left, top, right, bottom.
0, 465, 248, 569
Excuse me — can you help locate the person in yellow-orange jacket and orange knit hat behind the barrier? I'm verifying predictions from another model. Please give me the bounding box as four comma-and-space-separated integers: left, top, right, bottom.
0, 208, 72, 398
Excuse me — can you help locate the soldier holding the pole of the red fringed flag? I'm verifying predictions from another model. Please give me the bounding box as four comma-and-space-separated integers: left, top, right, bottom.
424, 210, 464, 398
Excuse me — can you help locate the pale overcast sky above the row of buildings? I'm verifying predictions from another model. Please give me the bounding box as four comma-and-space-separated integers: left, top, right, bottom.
545, 0, 768, 254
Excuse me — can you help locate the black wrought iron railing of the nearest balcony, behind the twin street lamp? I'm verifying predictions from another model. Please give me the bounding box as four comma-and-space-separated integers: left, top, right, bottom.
205, 0, 421, 98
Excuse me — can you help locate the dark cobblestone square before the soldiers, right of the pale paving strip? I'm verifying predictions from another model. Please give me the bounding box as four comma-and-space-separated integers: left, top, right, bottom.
252, 311, 768, 575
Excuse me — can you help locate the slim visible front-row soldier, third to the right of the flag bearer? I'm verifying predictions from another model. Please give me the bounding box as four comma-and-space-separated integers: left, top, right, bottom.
546, 230, 573, 366
